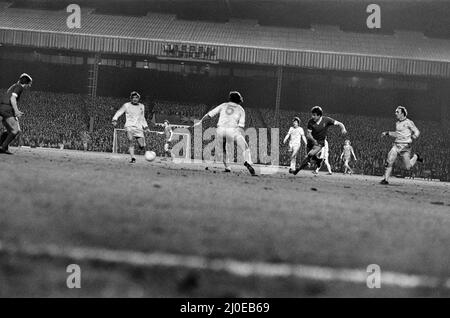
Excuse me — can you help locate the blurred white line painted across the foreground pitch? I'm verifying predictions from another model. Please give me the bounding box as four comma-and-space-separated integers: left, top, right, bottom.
0, 241, 450, 289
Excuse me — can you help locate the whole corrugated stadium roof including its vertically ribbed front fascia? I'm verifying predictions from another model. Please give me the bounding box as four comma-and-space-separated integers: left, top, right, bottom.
0, 2, 450, 77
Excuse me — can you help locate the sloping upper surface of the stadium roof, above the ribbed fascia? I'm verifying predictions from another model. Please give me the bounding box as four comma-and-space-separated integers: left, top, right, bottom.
0, 8, 450, 60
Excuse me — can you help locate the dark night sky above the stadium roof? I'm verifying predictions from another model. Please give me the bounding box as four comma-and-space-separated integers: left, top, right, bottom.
5, 0, 450, 39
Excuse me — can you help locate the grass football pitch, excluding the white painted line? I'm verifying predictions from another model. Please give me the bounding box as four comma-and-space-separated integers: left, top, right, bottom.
0, 148, 450, 297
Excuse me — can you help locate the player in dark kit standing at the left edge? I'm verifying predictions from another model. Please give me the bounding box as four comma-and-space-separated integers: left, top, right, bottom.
0, 73, 33, 155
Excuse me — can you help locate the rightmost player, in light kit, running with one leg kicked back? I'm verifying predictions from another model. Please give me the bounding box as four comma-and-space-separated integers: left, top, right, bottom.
380, 106, 423, 184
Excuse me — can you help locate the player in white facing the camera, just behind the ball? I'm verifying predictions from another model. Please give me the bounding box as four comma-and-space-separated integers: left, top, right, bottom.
112, 92, 149, 163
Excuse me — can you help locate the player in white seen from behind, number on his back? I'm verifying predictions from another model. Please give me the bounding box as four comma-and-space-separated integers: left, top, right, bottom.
194, 91, 256, 176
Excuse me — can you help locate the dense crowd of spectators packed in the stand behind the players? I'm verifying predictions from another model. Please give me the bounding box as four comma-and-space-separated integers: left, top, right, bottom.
0, 90, 450, 181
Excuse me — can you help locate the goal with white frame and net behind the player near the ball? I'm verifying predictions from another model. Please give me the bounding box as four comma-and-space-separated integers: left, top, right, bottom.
112, 128, 191, 159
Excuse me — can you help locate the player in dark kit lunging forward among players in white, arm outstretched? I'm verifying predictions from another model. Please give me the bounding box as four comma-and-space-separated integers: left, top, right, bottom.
292, 106, 347, 175
